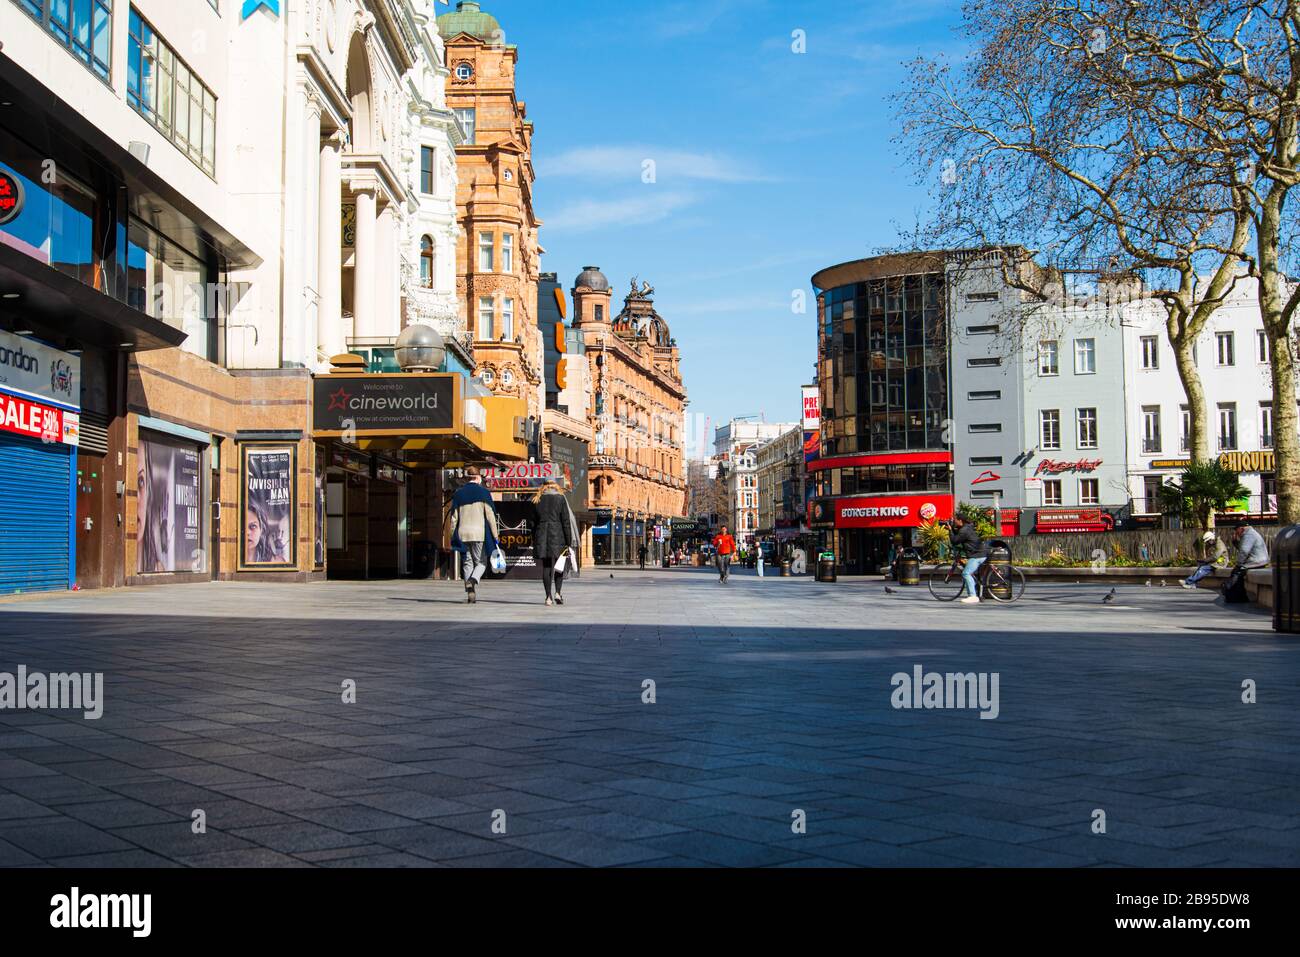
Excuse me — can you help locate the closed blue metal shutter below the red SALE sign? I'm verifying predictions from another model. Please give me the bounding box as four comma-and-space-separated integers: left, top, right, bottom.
0, 433, 73, 594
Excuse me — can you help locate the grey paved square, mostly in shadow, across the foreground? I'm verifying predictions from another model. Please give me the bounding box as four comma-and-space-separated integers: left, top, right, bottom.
0, 570, 1300, 867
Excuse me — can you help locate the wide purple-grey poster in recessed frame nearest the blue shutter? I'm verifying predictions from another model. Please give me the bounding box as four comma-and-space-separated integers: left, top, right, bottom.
135, 432, 207, 575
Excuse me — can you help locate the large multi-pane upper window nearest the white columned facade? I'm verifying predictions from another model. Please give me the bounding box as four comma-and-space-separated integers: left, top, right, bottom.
126, 7, 217, 177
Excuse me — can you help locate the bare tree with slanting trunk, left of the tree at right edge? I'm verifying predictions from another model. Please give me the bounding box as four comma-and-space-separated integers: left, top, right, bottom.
896, 0, 1251, 475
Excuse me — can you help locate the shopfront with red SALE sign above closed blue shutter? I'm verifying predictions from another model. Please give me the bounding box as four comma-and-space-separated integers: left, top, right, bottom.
0, 333, 81, 594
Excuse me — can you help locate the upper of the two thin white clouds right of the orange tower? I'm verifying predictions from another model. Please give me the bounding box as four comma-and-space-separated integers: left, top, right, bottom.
537, 146, 772, 187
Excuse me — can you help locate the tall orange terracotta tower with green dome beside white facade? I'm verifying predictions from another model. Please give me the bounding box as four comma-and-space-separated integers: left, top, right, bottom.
438, 3, 545, 421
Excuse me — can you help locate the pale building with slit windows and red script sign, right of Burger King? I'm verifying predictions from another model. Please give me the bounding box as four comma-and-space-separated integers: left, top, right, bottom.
949, 256, 1128, 524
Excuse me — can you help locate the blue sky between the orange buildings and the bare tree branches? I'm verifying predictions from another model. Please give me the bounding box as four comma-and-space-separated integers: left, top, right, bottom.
473, 0, 959, 455
